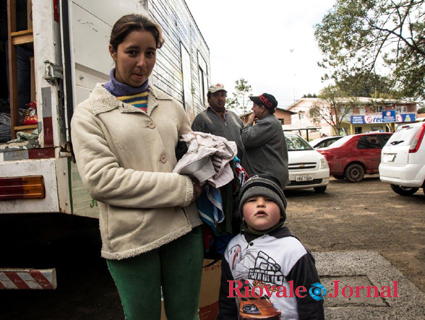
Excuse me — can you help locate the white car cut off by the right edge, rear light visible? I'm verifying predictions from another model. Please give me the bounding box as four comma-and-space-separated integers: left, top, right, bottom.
379, 122, 425, 196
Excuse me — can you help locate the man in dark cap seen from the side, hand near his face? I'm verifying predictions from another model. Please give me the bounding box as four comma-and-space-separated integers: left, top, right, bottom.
242, 93, 289, 189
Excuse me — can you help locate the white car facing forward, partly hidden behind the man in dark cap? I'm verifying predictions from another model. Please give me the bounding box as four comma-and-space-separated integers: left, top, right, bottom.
285, 132, 329, 193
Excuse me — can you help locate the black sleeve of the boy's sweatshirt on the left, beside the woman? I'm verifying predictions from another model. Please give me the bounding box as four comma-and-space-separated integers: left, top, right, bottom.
218, 258, 238, 320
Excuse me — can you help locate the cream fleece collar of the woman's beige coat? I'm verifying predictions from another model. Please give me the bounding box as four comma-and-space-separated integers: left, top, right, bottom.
89, 83, 171, 115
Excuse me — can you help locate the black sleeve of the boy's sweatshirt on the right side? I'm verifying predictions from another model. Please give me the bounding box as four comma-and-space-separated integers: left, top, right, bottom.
286, 250, 325, 320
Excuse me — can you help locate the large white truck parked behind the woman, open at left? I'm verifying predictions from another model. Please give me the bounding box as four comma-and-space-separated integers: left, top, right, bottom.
0, 0, 210, 289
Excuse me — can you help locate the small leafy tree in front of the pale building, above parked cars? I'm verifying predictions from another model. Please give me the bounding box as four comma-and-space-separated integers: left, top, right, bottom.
308, 85, 361, 134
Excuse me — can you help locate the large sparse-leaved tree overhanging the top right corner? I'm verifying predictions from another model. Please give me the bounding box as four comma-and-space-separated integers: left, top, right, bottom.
315, 0, 425, 98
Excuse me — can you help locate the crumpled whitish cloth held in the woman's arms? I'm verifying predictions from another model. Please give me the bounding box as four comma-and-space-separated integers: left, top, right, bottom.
173, 131, 238, 188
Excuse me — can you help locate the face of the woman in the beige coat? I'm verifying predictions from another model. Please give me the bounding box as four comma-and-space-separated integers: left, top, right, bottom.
109, 30, 156, 87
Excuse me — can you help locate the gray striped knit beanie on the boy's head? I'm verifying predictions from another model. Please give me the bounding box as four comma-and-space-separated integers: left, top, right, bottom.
238, 175, 287, 221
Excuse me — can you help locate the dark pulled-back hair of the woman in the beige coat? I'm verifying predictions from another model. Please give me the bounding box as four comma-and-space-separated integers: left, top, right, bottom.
109, 14, 164, 51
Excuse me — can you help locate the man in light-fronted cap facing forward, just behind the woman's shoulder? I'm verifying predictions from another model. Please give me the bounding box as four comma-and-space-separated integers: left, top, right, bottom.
192, 83, 244, 160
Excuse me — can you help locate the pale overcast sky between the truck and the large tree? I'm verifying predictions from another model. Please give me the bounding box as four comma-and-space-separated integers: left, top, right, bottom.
185, 0, 335, 108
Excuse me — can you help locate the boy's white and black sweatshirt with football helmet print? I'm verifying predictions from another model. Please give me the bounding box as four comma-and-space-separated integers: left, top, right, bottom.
219, 227, 324, 320
